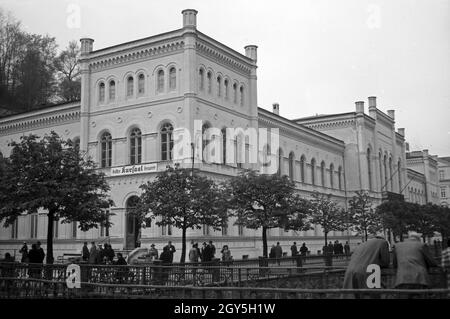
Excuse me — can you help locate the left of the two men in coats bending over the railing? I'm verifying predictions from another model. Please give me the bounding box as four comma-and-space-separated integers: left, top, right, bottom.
343, 236, 389, 289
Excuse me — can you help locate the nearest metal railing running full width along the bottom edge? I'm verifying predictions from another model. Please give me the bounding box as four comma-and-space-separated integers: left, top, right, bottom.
0, 278, 450, 299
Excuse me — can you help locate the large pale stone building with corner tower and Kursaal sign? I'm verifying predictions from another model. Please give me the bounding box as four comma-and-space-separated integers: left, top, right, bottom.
0, 10, 430, 258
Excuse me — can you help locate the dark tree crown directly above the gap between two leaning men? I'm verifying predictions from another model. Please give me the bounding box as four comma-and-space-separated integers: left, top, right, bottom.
376, 200, 412, 241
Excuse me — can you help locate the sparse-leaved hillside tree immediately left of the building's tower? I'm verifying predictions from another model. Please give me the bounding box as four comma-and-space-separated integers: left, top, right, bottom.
55, 41, 81, 102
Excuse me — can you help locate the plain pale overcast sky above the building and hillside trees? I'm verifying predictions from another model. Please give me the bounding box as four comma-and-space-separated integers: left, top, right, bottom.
0, 0, 450, 156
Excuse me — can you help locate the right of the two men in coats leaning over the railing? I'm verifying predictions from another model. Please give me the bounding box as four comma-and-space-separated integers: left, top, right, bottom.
393, 232, 437, 289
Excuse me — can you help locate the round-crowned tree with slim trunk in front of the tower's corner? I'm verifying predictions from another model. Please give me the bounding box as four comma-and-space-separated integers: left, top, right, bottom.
136, 168, 227, 263
